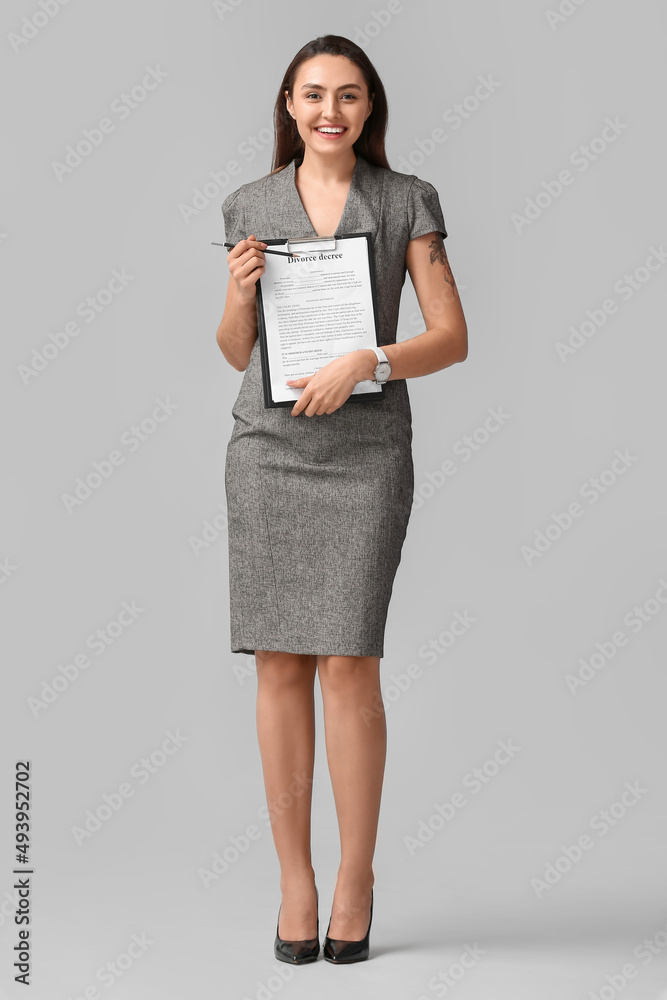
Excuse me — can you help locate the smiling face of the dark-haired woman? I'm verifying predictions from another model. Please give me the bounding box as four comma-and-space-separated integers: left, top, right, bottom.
285, 55, 373, 155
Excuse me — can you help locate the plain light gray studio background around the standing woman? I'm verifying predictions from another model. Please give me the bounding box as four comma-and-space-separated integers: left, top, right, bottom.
0, 0, 667, 1000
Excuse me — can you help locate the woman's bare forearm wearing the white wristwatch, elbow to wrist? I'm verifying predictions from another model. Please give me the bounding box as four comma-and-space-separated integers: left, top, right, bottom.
352, 323, 468, 382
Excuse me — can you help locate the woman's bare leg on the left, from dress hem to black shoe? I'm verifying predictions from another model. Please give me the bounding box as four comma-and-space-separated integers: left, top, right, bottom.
255, 649, 317, 941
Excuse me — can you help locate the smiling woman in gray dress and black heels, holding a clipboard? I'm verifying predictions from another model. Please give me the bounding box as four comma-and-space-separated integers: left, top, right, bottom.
217, 35, 467, 964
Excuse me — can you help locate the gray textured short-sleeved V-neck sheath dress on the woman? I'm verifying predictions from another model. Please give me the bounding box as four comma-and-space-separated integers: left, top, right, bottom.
222, 156, 447, 657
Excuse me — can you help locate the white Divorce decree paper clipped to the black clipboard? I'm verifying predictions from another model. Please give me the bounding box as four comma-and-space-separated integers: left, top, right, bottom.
258, 236, 382, 403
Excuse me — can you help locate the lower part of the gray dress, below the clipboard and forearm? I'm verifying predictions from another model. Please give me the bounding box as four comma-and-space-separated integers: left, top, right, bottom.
225, 341, 414, 657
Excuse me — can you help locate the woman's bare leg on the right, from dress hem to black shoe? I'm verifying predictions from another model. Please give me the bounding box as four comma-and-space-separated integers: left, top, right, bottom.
317, 656, 387, 941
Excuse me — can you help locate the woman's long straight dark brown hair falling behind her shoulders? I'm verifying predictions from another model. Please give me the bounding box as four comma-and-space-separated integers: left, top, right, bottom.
271, 35, 391, 174
